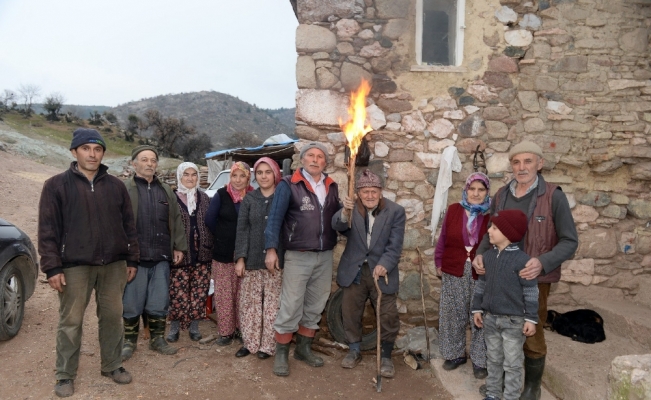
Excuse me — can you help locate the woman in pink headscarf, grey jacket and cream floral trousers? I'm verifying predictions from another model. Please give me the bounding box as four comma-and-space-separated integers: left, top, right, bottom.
235, 157, 283, 359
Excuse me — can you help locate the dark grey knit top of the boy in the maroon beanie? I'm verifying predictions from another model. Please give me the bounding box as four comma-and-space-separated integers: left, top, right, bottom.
472, 243, 538, 323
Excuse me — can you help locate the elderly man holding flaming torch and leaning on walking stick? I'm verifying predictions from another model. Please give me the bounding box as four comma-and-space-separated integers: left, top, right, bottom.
332, 169, 406, 378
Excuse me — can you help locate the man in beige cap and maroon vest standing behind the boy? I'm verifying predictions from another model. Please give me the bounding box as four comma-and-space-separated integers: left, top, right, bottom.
472, 141, 579, 400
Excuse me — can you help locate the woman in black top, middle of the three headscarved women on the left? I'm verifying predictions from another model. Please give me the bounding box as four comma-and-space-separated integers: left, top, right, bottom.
206, 161, 253, 346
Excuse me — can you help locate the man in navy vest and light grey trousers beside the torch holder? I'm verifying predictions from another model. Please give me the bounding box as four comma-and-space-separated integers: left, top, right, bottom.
264, 142, 341, 376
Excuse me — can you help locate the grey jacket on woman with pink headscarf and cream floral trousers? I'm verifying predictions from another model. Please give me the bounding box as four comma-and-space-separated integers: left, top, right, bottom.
233, 188, 284, 269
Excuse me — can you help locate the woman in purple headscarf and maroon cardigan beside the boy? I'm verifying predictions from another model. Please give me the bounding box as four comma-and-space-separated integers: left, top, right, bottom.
434, 172, 491, 379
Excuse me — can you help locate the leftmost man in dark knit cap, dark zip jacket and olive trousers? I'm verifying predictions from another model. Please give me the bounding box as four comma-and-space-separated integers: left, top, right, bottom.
38, 128, 138, 397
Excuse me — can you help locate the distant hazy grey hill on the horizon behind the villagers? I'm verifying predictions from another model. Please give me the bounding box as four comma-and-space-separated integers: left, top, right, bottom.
107, 91, 295, 150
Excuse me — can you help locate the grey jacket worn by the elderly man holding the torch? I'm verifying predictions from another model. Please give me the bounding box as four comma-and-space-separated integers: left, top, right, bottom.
332, 199, 406, 294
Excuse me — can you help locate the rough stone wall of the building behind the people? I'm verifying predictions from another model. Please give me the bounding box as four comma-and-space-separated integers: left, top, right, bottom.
296, 0, 651, 322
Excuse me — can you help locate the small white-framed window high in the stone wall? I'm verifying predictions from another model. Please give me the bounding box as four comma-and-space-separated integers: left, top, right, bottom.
416, 0, 466, 66
